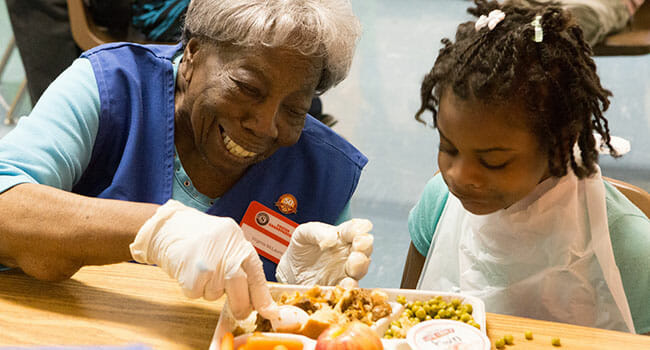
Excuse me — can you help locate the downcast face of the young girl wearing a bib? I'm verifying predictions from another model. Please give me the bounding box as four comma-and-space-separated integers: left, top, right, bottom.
437, 90, 549, 215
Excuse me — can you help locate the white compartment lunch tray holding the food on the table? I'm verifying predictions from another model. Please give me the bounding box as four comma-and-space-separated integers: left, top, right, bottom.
210, 284, 486, 350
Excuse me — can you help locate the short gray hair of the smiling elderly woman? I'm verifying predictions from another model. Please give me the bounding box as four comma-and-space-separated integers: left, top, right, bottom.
183, 0, 361, 93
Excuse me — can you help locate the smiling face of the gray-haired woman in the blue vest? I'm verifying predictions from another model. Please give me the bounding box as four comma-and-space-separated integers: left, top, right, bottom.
177, 39, 322, 178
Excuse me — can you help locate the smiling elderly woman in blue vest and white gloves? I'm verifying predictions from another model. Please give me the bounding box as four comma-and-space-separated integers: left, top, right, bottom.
0, 0, 372, 316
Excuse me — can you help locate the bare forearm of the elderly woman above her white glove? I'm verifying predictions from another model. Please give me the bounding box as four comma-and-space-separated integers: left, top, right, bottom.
0, 184, 158, 280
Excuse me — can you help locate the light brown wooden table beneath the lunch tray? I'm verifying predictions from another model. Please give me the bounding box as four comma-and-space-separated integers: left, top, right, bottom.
0, 263, 650, 350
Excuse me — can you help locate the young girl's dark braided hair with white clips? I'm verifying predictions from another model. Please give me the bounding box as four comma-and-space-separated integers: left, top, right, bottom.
415, 0, 618, 178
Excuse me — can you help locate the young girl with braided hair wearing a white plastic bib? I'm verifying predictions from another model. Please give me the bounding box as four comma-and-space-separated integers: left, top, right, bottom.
402, 0, 650, 333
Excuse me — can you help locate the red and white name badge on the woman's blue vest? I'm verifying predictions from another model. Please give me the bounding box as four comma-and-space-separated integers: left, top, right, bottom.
241, 201, 298, 264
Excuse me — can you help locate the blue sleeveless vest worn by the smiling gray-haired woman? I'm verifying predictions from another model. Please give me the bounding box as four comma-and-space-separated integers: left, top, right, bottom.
73, 43, 368, 281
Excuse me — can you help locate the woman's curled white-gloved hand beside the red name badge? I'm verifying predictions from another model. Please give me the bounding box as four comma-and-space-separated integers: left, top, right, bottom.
275, 219, 373, 287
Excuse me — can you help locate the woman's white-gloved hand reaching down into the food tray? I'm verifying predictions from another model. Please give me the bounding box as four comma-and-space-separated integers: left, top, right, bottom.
129, 200, 273, 319
